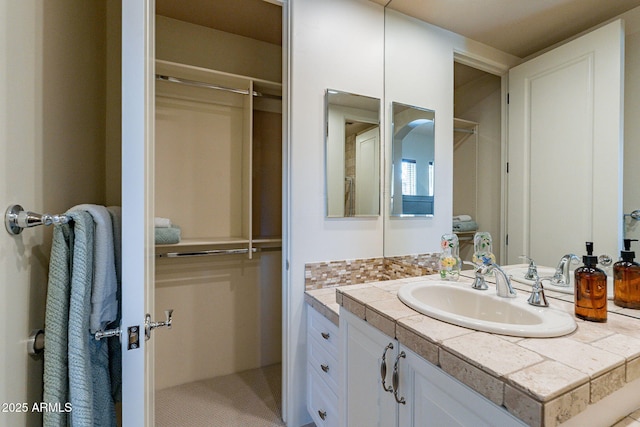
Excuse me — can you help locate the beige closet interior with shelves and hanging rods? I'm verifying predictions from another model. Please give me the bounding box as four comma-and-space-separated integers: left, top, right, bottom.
153, 0, 282, 426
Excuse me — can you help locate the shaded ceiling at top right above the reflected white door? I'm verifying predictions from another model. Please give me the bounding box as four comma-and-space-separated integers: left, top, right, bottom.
372, 0, 640, 58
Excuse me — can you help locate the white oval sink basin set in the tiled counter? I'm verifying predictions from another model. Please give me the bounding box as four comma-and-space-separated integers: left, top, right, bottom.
398, 280, 576, 338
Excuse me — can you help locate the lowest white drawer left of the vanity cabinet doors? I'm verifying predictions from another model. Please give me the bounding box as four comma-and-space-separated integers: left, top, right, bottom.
307, 366, 339, 427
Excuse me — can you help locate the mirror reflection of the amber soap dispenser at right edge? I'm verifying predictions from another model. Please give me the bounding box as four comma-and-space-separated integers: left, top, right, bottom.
613, 239, 640, 309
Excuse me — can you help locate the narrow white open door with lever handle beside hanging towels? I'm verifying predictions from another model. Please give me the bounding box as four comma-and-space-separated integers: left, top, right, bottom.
121, 0, 155, 427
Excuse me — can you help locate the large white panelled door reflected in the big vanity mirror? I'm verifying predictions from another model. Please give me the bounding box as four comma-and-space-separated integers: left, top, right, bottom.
507, 21, 624, 267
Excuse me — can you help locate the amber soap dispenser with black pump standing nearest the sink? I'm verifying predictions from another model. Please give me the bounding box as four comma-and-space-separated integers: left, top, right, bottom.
574, 242, 607, 322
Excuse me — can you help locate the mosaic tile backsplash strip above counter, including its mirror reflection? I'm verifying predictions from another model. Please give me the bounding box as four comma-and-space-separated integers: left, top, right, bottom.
304, 253, 439, 290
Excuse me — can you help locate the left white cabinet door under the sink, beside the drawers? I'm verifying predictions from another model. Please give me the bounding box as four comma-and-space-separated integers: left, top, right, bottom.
340, 310, 398, 427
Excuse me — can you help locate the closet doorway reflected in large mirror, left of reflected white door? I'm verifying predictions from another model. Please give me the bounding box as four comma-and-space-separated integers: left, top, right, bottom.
453, 62, 504, 262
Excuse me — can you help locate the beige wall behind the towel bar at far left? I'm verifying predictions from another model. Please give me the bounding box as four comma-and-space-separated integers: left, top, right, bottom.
0, 0, 106, 426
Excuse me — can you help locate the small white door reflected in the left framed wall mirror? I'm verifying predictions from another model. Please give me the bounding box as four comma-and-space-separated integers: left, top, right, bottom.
356, 126, 380, 215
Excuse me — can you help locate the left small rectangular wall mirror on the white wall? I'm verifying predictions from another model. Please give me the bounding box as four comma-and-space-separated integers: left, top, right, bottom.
325, 89, 380, 218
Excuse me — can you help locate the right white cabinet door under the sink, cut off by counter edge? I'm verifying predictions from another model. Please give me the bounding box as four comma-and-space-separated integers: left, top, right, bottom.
399, 346, 526, 427
